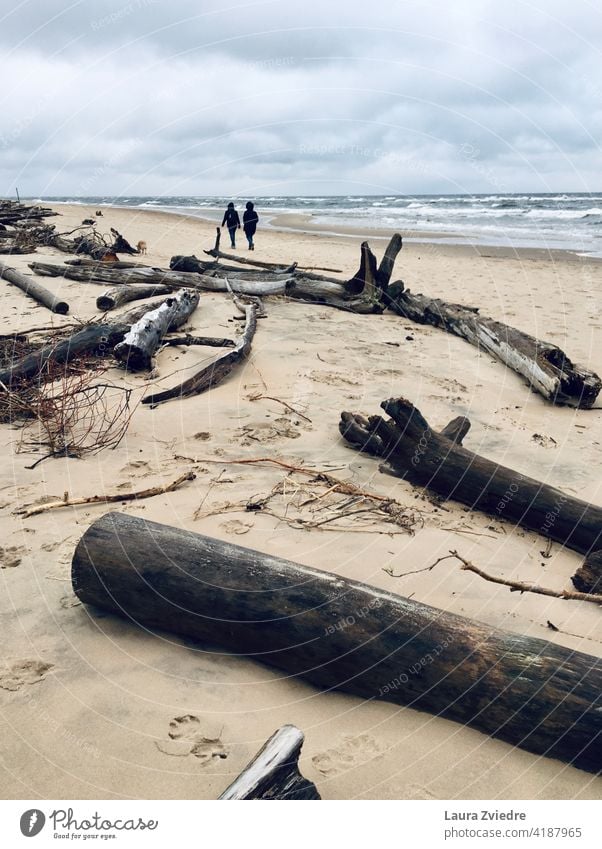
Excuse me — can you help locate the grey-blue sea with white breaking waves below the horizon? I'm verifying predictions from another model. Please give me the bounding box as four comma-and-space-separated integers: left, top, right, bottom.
37, 192, 602, 258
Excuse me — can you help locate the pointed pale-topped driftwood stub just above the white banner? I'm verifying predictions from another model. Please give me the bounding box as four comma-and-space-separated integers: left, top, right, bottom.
219, 725, 320, 800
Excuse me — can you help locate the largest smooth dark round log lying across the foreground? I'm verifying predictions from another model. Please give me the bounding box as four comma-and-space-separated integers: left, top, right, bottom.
72, 513, 602, 772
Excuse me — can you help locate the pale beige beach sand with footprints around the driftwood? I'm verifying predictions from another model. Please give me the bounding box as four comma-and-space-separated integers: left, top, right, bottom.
0, 206, 602, 799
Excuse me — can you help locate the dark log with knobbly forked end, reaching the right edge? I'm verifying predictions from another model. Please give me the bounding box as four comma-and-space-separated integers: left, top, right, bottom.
339, 398, 602, 553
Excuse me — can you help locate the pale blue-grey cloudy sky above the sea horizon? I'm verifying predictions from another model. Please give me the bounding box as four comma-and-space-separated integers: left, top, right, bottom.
0, 0, 602, 197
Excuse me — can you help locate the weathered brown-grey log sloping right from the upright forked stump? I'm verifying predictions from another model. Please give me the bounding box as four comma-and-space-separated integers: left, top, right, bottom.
387, 281, 602, 409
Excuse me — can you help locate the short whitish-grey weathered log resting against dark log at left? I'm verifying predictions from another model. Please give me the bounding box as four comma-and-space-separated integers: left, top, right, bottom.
113, 289, 199, 371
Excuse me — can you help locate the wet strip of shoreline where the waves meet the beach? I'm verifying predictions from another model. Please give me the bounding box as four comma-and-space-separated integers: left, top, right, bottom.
36, 199, 602, 264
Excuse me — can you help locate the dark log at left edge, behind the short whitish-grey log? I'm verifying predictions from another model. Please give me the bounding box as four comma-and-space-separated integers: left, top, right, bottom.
0, 304, 171, 386
